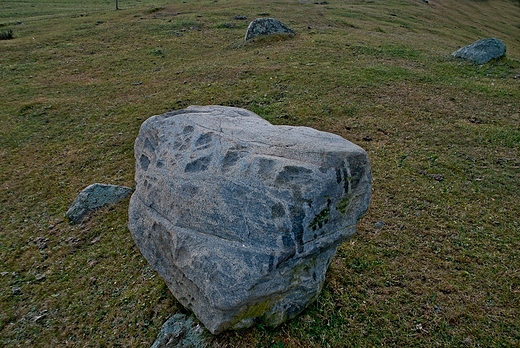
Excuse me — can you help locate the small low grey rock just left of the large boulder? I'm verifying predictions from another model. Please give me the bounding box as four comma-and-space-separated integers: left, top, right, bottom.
65, 184, 132, 224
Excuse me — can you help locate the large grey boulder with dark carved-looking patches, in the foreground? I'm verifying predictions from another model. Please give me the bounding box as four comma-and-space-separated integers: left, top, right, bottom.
129, 106, 371, 334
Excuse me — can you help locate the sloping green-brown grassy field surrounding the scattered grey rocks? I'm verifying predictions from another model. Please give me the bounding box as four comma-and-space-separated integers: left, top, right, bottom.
0, 0, 520, 347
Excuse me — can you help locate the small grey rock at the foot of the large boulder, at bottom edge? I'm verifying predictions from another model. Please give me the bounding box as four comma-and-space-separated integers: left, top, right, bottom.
151, 314, 207, 348
